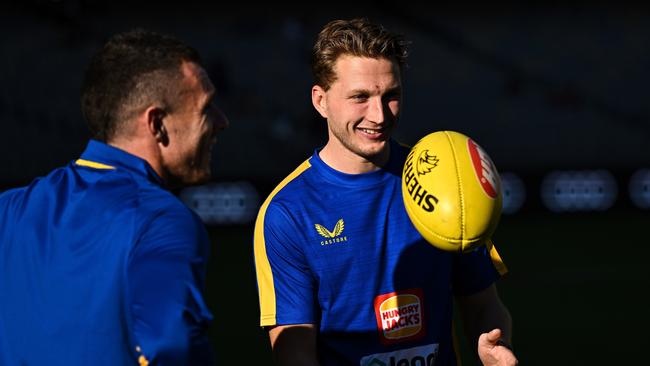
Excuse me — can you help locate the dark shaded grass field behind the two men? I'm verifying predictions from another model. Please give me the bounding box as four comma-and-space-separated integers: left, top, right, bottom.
207, 212, 650, 365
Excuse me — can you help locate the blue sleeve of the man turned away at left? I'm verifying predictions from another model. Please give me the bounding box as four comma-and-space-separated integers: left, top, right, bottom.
127, 205, 213, 365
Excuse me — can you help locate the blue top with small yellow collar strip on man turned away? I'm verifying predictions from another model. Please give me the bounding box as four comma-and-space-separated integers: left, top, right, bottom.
0, 141, 212, 366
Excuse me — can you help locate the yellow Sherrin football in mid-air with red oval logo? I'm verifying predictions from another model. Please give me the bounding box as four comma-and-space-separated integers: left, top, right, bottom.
402, 131, 502, 252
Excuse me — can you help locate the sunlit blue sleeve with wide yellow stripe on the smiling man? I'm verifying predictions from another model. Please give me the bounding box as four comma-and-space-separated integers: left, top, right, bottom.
254, 203, 317, 326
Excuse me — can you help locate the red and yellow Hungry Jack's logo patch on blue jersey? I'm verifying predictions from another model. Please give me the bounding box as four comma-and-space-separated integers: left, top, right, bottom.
374, 288, 426, 345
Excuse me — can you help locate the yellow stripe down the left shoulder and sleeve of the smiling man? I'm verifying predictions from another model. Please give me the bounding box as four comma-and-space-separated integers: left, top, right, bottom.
253, 160, 311, 327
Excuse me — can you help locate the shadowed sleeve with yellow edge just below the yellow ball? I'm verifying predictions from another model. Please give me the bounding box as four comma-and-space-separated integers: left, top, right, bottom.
452, 240, 507, 296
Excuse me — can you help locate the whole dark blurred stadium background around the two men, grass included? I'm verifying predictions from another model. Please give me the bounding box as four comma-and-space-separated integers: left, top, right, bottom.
0, 0, 650, 365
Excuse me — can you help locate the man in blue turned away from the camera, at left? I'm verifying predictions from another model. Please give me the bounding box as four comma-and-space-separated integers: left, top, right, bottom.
0, 30, 228, 366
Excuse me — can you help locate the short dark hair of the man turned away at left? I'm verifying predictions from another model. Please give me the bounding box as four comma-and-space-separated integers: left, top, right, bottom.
81, 29, 200, 142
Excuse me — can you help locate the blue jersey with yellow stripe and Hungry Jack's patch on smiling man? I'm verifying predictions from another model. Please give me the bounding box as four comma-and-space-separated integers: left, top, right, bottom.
254, 141, 505, 365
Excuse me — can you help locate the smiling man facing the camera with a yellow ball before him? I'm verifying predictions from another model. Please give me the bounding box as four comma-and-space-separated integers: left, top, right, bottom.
254, 19, 517, 366
